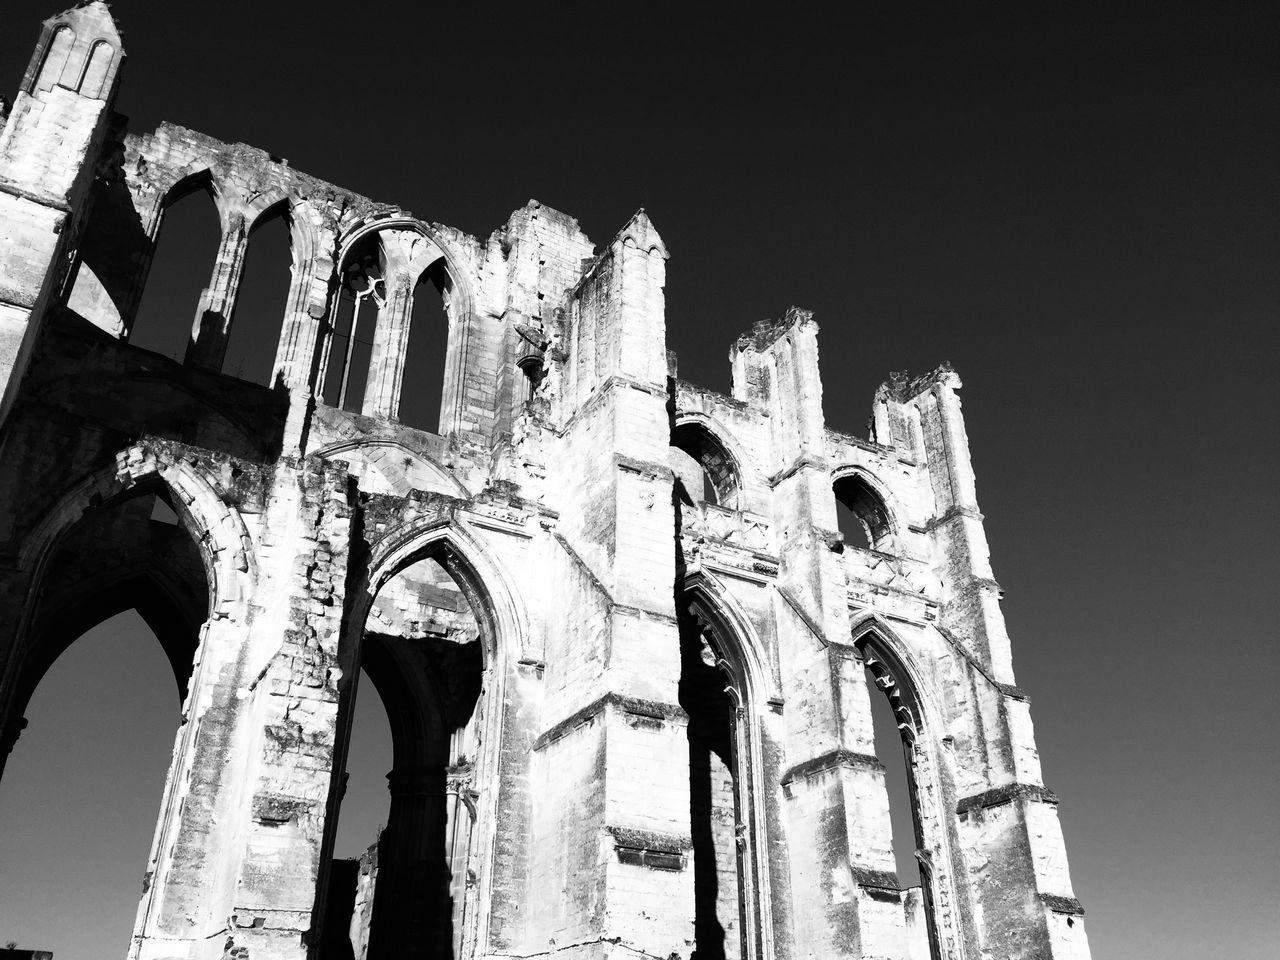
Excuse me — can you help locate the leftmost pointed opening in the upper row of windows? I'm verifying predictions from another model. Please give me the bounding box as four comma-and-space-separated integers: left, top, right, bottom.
129, 180, 221, 362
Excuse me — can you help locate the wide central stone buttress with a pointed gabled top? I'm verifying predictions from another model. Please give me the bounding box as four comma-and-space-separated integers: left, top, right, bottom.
513, 211, 694, 957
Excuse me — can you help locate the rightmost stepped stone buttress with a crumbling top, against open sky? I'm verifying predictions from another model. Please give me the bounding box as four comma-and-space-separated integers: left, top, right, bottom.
890, 366, 1088, 960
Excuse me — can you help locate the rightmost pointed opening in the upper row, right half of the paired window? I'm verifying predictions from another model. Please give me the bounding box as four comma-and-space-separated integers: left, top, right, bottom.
399, 259, 453, 433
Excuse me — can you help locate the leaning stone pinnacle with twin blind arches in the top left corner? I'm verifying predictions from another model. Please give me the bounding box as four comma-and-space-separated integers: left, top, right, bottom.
0, 3, 124, 422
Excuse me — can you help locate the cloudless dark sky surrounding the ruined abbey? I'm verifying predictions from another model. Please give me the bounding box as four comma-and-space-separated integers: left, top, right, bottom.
0, 0, 1280, 960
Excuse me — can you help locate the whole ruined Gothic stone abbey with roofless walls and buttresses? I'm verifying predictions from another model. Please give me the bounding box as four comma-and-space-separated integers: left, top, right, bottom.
0, 3, 1089, 960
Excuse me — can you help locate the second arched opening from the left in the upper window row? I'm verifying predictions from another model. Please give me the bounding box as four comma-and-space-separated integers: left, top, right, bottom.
223, 205, 293, 387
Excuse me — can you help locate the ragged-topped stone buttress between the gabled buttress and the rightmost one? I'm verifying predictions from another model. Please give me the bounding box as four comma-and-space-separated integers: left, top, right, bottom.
732, 307, 906, 957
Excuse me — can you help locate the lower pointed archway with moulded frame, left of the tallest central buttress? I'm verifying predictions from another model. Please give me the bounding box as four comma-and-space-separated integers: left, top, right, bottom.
314, 522, 511, 960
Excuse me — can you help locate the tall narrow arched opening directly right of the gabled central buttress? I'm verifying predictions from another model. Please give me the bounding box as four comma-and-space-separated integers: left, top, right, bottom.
680, 596, 758, 960
